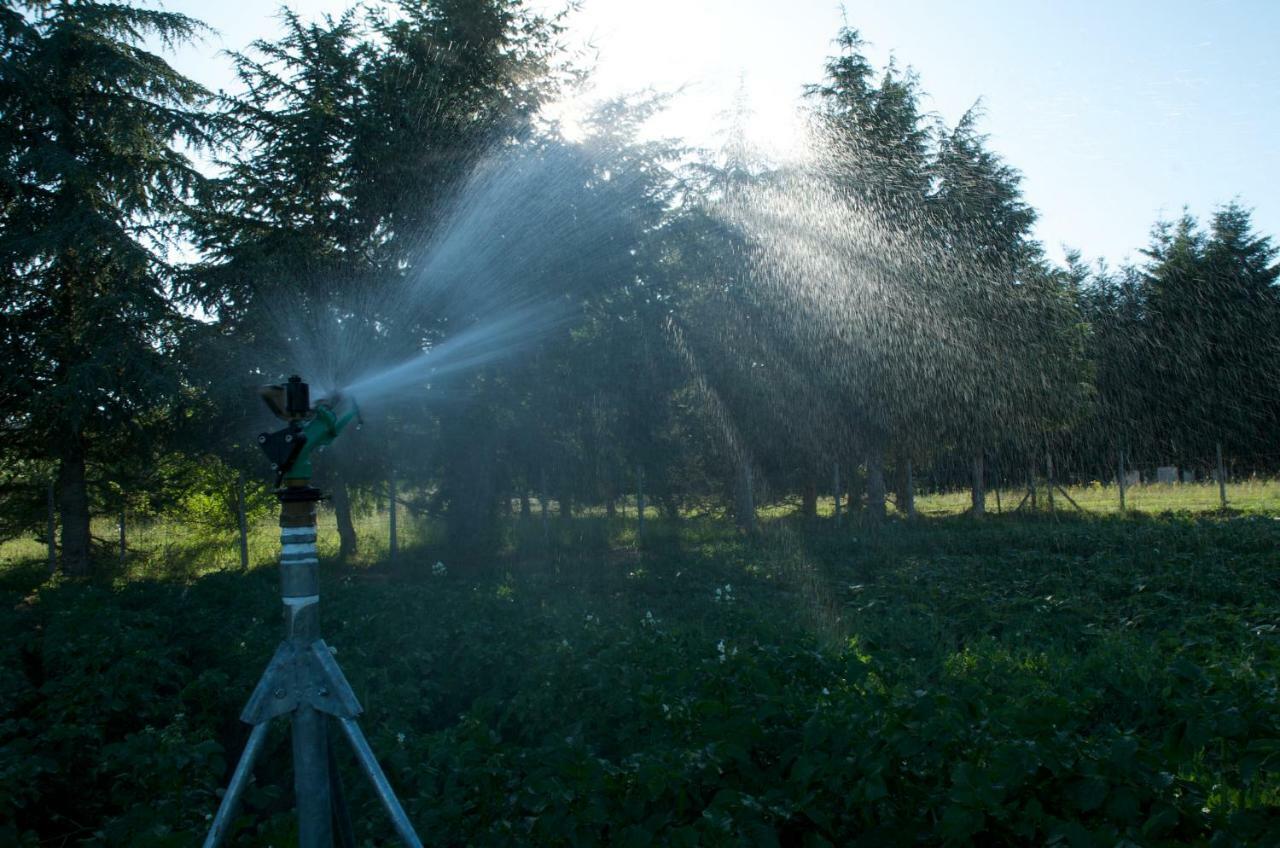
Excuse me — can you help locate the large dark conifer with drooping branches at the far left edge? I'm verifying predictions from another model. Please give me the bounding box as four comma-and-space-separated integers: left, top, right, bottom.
0, 0, 214, 574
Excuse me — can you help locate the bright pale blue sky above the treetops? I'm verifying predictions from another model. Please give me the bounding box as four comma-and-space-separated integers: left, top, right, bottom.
154, 0, 1280, 264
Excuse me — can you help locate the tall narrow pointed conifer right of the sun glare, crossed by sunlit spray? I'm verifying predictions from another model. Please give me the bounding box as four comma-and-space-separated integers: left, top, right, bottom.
805, 27, 941, 515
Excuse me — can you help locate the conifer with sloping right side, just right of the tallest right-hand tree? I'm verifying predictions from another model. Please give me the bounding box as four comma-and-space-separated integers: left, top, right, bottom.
928, 109, 1084, 479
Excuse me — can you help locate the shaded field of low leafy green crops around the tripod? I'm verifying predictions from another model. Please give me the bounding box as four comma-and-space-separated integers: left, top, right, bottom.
0, 489, 1280, 845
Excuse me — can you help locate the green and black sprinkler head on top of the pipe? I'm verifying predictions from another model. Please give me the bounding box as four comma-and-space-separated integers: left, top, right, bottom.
257, 375, 360, 487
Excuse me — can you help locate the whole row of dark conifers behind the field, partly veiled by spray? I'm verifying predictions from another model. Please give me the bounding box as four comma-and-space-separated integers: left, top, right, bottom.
0, 0, 1280, 574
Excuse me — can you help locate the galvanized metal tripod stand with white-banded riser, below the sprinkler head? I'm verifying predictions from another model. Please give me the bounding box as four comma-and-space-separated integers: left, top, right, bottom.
205, 478, 422, 848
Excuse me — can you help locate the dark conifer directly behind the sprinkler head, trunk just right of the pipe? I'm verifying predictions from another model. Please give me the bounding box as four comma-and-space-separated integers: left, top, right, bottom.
183, 10, 373, 557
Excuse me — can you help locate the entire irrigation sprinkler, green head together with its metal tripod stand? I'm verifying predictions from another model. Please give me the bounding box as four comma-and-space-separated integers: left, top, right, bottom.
205, 377, 422, 848
